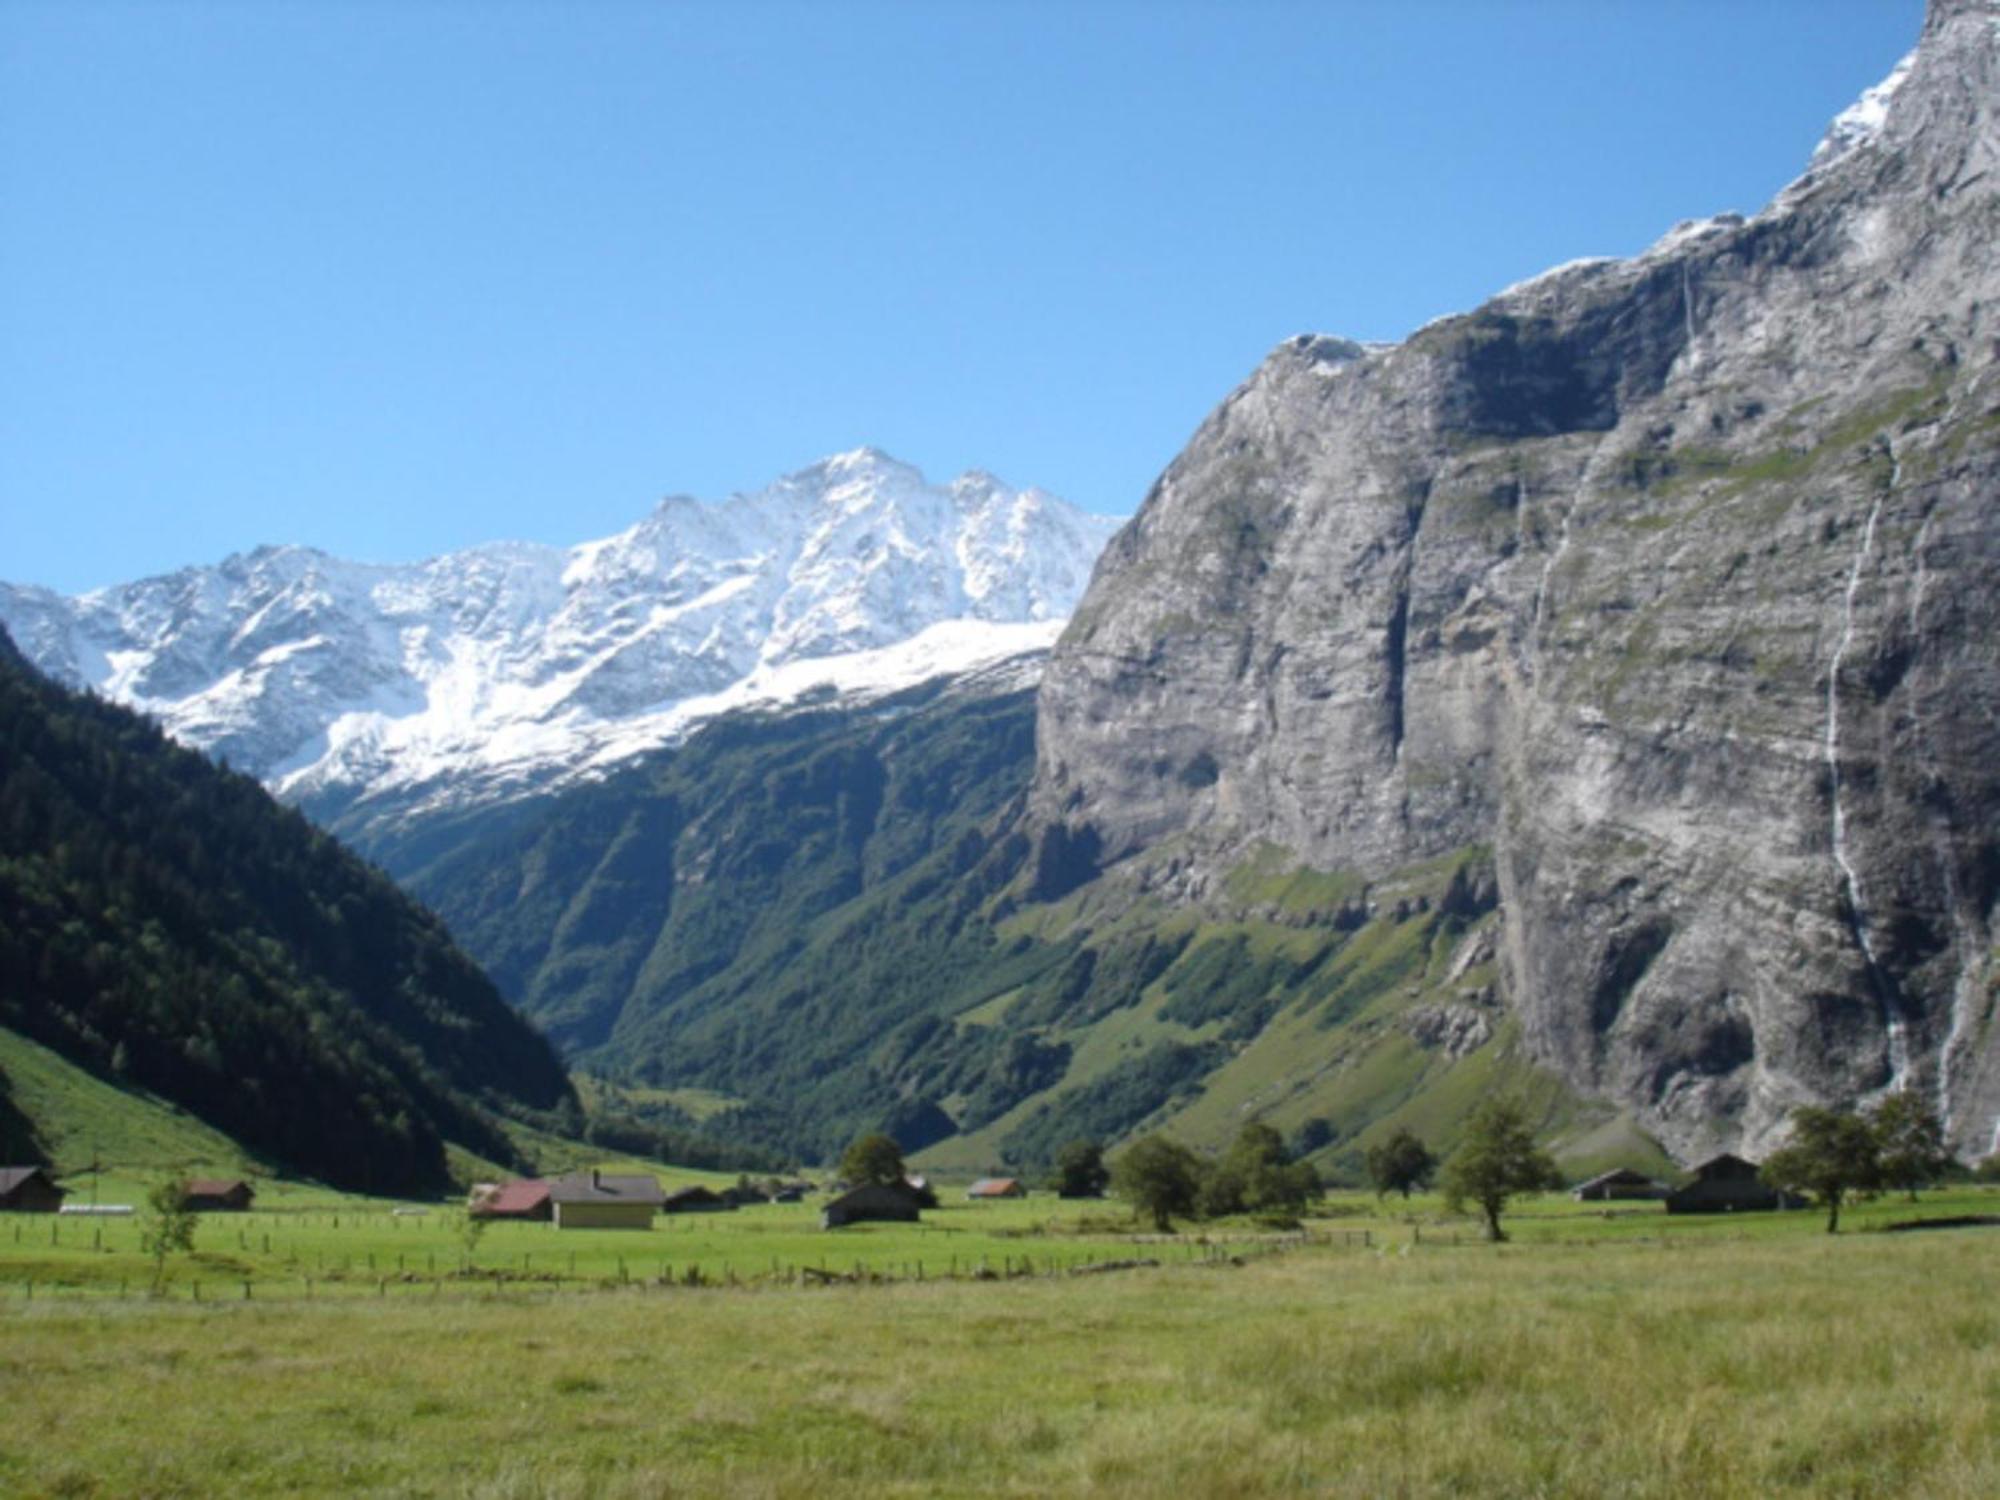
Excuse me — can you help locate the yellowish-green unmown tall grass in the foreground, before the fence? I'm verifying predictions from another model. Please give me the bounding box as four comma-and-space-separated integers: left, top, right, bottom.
0, 1230, 2000, 1500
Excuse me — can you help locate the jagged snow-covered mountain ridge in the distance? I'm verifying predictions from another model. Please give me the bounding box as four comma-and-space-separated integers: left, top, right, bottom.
0, 448, 1116, 840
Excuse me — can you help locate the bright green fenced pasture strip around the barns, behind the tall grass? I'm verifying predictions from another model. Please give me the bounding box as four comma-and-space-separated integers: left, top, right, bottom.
0, 1162, 2000, 1304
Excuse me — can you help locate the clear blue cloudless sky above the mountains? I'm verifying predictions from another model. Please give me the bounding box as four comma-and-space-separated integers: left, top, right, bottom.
0, 0, 1922, 590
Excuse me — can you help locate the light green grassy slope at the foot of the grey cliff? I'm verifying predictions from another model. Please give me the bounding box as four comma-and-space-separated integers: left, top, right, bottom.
922, 850, 1672, 1182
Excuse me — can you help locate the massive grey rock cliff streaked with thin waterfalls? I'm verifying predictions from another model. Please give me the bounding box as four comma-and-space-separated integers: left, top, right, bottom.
1032, 0, 2000, 1154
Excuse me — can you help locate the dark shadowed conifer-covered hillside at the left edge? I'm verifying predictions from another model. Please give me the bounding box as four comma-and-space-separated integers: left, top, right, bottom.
0, 636, 572, 1192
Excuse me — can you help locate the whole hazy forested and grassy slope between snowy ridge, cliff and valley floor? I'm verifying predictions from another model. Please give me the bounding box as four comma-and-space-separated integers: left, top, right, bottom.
380, 668, 1646, 1174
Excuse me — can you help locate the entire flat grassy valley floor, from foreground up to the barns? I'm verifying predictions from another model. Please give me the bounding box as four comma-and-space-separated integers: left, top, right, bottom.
0, 1174, 2000, 1498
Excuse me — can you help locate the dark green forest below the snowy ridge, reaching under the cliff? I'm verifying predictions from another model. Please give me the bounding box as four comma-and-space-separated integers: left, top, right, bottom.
372, 684, 1440, 1170
